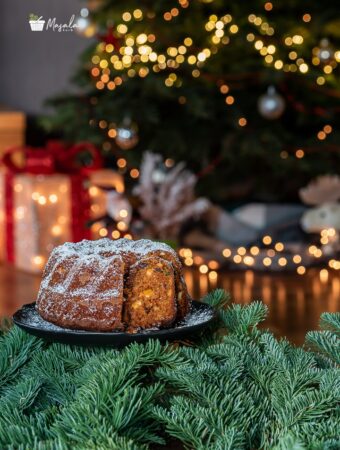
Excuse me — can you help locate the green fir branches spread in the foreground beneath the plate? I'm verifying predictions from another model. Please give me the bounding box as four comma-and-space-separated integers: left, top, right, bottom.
0, 290, 340, 450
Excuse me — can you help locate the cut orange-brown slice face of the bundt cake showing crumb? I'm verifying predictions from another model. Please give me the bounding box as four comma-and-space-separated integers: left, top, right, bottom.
124, 256, 177, 332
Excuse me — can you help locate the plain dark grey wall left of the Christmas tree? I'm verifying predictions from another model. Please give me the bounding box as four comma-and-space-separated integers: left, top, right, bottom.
0, 0, 89, 115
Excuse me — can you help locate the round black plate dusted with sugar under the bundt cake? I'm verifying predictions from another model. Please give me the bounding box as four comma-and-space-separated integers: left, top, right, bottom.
13, 301, 215, 347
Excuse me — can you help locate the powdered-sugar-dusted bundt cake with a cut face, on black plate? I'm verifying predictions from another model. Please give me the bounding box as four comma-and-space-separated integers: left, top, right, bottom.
37, 239, 191, 332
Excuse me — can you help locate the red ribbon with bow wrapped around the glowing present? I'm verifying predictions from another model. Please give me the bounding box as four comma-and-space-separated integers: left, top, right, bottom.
2, 141, 103, 263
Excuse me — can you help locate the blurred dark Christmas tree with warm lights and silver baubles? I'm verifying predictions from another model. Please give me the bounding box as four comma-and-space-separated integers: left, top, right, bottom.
45, 0, 340, 202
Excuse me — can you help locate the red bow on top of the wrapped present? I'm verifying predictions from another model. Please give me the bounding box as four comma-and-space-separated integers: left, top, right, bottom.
2, 141, 103, 175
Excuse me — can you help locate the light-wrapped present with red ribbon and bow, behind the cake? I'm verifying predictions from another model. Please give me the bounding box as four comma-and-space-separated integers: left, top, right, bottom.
0, 142, 124, 272
